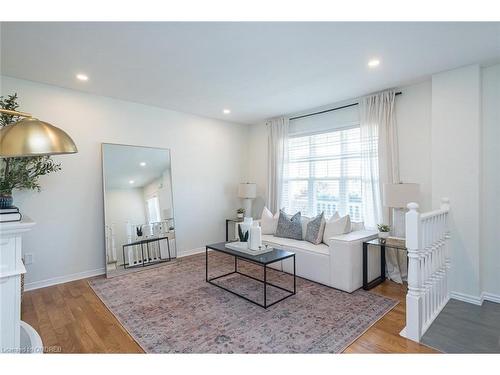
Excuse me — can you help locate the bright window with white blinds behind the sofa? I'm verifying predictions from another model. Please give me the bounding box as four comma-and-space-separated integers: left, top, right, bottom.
282, 127, 363, 221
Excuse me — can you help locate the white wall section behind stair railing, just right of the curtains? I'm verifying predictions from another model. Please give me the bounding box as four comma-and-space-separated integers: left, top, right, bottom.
431, 65, 481, 297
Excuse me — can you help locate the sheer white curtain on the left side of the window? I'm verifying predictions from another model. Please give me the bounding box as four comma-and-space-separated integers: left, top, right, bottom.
266, 117, 289, 214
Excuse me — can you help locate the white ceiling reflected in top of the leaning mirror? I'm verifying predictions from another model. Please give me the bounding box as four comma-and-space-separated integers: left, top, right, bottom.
103, 144, 170, 190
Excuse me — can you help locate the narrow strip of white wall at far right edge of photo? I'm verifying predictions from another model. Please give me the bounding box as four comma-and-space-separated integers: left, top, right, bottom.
480, 65, 500, 296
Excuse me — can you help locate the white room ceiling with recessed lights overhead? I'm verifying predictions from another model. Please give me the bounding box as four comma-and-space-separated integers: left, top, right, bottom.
1, 22, 500, 123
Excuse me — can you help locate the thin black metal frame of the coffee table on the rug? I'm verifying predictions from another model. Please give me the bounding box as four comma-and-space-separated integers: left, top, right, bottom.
205, 246, 297, 309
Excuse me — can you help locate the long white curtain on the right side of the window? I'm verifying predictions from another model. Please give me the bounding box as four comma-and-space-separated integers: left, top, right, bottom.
359, 90, 407, 283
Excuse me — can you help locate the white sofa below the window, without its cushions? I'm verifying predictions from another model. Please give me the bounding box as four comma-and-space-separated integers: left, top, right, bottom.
262, 229, 379, 293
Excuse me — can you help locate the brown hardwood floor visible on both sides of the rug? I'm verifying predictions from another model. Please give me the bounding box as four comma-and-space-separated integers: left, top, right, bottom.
22, 279, 435, 353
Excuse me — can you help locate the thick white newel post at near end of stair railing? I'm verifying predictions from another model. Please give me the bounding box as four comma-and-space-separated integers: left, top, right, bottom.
405, 202, 422, 341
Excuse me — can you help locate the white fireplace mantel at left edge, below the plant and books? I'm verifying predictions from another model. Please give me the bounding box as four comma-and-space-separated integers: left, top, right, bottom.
0, 218, 42, 353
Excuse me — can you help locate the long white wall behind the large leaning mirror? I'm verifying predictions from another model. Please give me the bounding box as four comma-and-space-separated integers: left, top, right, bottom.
1, 77, 248, 287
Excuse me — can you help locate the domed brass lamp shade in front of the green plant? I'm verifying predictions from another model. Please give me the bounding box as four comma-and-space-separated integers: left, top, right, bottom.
0, 117, 78, 158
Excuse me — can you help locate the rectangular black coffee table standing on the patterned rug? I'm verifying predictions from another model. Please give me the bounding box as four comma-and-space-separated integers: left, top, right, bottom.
205, 242, 296, 309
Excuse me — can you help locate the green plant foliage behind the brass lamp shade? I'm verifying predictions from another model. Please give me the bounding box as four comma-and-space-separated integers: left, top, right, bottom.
0, 94, 61, 195
